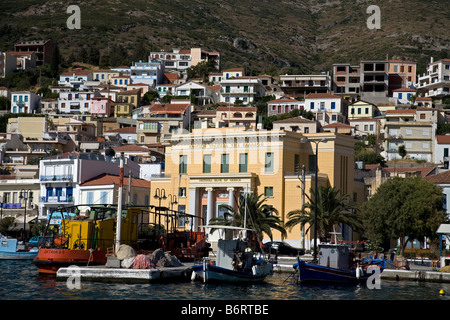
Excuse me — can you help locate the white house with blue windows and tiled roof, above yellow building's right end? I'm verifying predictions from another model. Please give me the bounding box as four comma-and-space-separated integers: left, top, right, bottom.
305, 93, 347, 126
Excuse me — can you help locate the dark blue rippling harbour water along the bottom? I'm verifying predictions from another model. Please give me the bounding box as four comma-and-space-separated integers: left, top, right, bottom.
0, 260, 450, 301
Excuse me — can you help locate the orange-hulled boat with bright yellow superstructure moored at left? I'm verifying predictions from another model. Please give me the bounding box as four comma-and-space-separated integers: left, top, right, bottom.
33, 207, 140, 274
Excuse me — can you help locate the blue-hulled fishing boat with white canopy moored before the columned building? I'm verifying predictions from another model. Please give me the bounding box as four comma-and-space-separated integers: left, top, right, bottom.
192, 226, 273, 283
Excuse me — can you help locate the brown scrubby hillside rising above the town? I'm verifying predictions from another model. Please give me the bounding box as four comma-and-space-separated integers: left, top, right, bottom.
0, 0, 450, 74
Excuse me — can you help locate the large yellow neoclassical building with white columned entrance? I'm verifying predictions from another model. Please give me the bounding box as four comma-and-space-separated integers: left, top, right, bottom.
151, 127, 354, 248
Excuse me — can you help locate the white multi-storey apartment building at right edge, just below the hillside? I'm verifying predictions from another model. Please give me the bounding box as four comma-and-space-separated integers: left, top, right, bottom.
417, 58, 450, 100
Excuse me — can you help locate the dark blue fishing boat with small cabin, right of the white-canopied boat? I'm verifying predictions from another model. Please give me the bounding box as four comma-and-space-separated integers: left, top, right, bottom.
294, 244, 382, 284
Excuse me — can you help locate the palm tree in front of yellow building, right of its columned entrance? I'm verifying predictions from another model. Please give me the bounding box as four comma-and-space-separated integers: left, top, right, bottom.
210, 194, 286, 240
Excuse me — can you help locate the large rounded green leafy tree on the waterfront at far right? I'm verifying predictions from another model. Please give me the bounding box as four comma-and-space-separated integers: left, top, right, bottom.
360, 176, 445, 254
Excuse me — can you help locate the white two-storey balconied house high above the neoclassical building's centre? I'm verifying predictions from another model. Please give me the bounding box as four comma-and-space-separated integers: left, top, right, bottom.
220, 76, 265, 105
